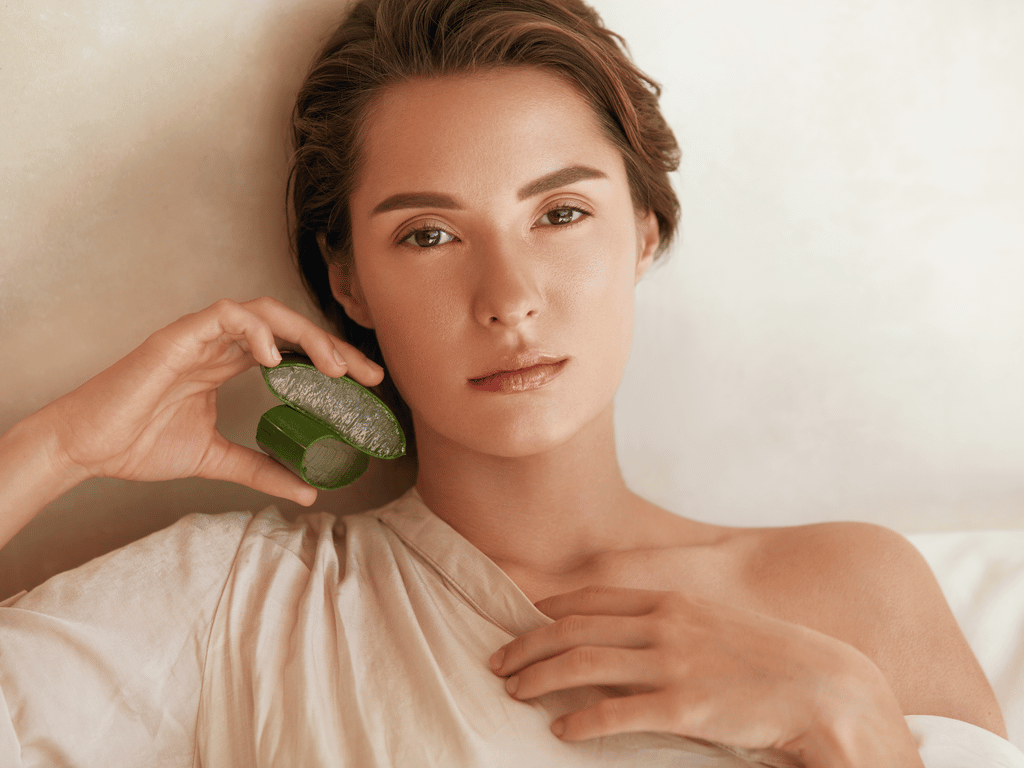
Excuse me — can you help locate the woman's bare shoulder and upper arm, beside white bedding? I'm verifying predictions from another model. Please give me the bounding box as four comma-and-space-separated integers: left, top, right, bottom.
722, 522, 1006, 736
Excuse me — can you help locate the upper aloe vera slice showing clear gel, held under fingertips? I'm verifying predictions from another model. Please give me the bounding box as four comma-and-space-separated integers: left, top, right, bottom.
263, 354, 406, 459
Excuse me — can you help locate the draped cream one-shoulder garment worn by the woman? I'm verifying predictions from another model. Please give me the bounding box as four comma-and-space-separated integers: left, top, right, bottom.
0, 490, 1024, 768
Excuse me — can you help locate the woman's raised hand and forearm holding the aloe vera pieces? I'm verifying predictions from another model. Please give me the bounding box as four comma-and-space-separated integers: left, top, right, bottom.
0, 298, 383, 545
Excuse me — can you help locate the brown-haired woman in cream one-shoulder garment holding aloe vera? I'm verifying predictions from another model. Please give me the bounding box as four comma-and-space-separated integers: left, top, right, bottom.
0, 0, 1014, 766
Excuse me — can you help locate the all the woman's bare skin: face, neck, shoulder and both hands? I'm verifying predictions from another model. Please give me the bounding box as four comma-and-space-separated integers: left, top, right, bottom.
0, 69, 1005, 768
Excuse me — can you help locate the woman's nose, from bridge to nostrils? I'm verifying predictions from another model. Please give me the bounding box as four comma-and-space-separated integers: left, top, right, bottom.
473, 237, 544, 328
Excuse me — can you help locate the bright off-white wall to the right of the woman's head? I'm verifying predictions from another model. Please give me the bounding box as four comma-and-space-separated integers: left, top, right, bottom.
605, 0, 1024, 531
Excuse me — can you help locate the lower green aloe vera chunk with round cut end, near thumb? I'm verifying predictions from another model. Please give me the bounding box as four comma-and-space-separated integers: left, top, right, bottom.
256, 406, 370, 490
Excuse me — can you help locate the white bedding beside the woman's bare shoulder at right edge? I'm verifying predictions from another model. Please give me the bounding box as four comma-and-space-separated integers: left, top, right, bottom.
907, 530, 1024, 749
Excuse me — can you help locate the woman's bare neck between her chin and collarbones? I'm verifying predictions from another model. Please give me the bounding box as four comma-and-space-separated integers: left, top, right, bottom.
416, 404, 649, 575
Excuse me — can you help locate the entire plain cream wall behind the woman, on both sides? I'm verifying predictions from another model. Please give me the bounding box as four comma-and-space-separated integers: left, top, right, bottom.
0, 0, 1024, 597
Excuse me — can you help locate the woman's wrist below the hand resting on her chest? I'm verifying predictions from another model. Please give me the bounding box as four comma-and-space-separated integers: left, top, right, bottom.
790, 646, 924, 768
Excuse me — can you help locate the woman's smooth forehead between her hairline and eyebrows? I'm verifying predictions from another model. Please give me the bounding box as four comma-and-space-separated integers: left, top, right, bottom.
353, 68, 625, 207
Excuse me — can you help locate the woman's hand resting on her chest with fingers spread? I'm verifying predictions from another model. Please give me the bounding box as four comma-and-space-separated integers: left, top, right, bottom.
492, 587, 922, 768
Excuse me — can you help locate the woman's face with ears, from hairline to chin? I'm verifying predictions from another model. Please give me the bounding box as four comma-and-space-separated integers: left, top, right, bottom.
332, 68, 657, 457
